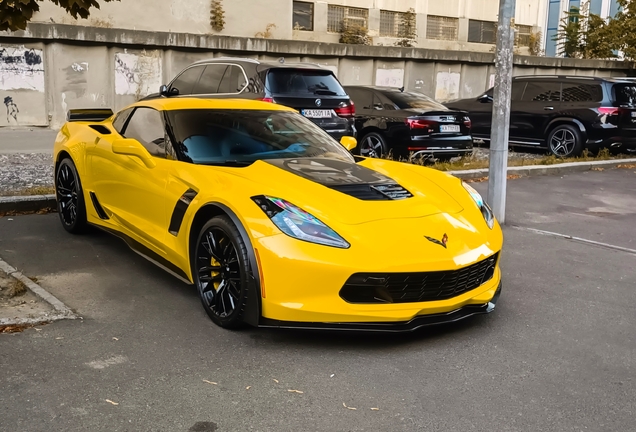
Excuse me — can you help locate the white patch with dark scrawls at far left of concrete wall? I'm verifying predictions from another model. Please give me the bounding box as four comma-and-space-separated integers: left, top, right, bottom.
0, 46, 44, 92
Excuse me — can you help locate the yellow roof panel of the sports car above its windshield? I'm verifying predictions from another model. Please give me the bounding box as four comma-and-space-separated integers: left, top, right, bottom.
131, 97, 295, 112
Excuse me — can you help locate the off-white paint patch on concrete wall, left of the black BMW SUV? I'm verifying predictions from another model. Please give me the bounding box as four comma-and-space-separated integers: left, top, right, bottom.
115, 52, 161, 99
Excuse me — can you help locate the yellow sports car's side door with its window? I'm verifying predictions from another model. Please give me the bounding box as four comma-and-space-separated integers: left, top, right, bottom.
90, 107, 171, 253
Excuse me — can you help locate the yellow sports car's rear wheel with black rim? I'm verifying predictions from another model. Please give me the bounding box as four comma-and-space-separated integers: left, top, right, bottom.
55, 158, 88, 234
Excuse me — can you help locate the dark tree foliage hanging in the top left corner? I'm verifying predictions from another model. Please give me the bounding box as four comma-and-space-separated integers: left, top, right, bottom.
0, 0, 119, 31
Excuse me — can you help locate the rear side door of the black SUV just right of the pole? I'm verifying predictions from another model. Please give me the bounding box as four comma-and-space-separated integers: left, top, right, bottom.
510, 79, 561, 146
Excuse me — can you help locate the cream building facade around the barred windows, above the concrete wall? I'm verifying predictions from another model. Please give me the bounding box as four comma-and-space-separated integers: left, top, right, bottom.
33, 0, 547, 52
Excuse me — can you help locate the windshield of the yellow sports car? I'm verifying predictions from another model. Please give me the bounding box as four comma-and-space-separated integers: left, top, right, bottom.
167, 109, 354, 166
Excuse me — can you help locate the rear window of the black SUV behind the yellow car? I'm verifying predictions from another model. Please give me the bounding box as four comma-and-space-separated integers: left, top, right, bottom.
267, 69, 347, 96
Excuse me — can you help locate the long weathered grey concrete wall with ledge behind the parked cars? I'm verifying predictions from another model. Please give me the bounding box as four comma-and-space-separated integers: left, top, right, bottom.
0, 24, 633, 127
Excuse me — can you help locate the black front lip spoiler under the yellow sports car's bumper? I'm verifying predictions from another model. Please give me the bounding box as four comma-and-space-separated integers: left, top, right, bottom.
258, 282, 501, 333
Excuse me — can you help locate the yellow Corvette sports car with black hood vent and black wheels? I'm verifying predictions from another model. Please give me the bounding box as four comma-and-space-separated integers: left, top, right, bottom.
54, 98, 503, 331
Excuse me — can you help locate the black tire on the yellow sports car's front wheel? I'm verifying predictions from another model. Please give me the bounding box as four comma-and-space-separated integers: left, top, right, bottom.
190, 216, 251, 329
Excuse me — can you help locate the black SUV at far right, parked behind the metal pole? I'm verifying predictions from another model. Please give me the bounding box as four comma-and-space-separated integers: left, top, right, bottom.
446, 76, 636, 157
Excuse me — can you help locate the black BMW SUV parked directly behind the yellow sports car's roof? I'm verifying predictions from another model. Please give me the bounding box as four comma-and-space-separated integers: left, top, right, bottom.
148, 58, 355, 140
